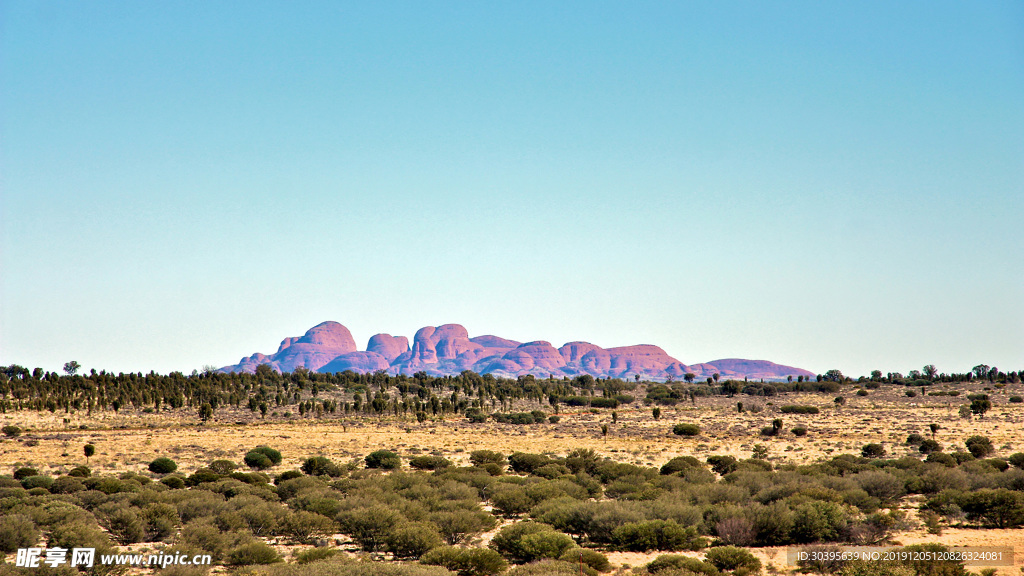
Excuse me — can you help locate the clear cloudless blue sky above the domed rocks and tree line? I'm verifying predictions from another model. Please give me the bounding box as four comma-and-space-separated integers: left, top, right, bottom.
0, 0, 1024, 375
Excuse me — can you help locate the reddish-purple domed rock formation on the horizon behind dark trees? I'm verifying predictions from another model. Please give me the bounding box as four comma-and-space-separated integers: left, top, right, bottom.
220, 322, 814, 380
